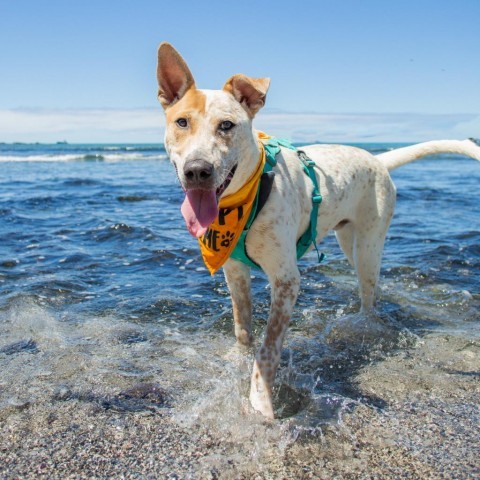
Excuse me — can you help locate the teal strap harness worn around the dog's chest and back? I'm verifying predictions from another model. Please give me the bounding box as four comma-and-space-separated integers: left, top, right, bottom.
230, 138, 325, 268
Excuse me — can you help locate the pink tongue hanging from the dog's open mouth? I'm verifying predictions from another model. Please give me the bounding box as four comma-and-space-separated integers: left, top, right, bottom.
181, 190, 218, 238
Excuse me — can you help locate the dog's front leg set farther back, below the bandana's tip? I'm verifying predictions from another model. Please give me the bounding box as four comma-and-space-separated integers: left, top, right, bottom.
223, 259, 252, 346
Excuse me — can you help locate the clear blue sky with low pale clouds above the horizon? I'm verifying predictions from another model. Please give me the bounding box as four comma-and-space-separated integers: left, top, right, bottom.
0, 0, 480, 142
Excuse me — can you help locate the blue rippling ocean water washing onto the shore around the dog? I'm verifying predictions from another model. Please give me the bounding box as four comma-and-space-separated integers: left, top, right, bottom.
0, 144, 480, 472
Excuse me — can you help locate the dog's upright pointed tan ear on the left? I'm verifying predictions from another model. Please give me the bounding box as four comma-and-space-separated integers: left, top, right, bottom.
157, 42, 195, 108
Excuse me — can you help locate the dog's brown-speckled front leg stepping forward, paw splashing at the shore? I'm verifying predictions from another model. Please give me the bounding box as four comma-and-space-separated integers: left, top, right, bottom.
250, 265, 300, 419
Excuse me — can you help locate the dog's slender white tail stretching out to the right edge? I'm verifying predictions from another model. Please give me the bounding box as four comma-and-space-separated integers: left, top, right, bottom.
377, 138, 480, 171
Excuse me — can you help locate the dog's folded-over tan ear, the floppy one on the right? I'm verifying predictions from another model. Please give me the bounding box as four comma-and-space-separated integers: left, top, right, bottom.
223, 74, 270, 118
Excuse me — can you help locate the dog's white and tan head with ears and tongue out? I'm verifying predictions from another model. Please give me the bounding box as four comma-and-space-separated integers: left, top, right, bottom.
157, 43, 270, 237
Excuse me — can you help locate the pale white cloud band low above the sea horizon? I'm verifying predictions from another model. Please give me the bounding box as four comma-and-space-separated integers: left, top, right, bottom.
0, 107, 480, 143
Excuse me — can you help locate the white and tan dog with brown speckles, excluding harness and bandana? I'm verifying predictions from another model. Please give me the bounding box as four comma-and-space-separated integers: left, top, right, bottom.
157, 43, 480, 418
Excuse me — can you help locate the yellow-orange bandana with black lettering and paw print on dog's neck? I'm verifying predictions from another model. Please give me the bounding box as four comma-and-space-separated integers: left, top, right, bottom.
198, 132, 270, 275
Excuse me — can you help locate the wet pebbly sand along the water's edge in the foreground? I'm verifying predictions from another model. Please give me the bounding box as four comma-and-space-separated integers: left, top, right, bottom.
0, 333, 480, 479
